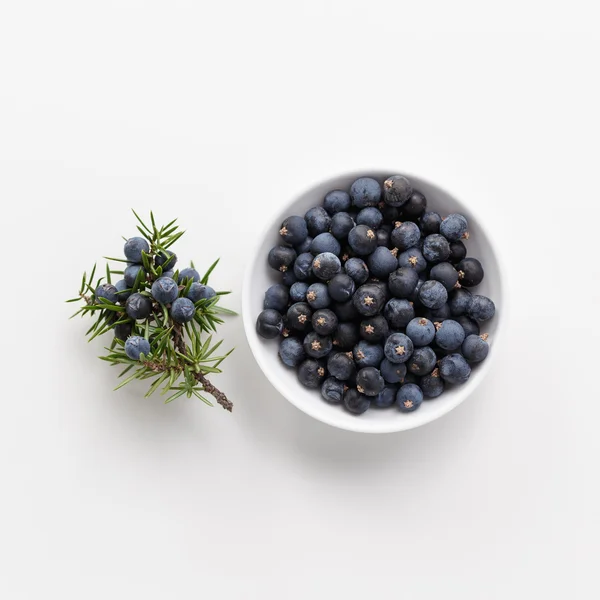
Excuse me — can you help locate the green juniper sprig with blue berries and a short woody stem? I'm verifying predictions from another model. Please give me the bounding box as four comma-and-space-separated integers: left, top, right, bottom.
67, 211, 236, 411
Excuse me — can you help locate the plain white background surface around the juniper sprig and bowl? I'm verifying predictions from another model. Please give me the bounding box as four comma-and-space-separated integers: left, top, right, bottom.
0, 0, 600, 600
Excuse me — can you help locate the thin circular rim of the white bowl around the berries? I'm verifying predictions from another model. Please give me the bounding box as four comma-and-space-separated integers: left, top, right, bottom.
242, 168, 508, 434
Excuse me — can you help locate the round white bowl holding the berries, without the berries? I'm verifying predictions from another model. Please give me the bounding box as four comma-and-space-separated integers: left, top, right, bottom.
242, 171, 505, 433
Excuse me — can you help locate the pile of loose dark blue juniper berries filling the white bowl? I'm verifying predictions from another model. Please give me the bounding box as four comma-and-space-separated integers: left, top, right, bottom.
256, 175, 495, 415
